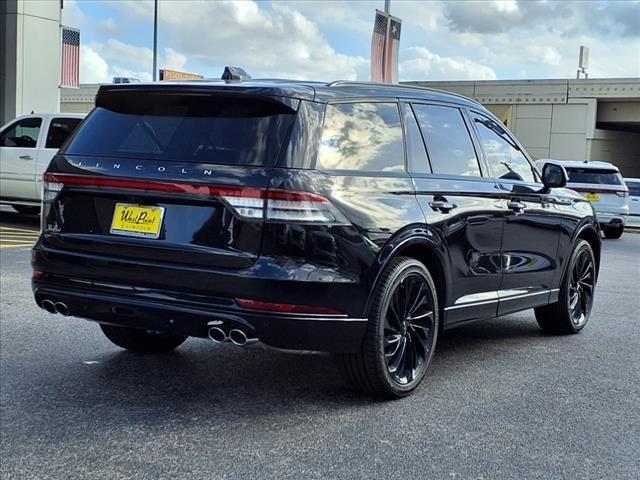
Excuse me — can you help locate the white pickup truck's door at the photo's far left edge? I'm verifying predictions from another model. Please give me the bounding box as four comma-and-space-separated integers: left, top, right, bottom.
0, 117, 42, 200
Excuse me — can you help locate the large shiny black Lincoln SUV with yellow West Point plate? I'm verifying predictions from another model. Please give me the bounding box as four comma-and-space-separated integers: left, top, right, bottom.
33, 81, 600, 397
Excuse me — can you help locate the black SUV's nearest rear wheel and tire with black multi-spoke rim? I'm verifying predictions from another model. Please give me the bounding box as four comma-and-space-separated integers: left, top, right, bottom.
337, 257, 439, 398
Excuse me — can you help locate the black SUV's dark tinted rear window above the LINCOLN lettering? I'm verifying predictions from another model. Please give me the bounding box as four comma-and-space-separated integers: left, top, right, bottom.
64, 92, 295, 166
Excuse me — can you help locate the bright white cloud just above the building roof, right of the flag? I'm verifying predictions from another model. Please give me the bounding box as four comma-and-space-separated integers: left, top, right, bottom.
399, 47, 496, 80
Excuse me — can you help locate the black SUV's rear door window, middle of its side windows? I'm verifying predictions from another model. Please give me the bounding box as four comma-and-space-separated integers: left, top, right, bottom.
413, 104, 480, 177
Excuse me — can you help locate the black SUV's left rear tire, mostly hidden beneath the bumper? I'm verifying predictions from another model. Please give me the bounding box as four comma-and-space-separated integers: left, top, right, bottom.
100, 323, 187, 353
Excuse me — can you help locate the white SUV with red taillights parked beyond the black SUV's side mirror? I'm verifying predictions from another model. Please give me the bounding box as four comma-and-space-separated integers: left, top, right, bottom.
536, 159, 629, 238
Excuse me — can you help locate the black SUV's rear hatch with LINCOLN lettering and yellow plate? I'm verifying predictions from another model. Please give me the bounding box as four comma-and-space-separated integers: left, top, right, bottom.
43, 87, 298, 268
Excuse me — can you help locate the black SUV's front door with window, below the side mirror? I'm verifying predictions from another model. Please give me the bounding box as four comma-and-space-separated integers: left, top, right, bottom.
469, 111, 562, 315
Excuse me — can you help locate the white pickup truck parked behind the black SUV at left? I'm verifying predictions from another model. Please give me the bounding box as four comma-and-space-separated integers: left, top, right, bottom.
0, 113, 85, 214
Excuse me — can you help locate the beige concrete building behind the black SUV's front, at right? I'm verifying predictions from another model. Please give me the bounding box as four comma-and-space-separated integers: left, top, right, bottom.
408, 78, 640, 177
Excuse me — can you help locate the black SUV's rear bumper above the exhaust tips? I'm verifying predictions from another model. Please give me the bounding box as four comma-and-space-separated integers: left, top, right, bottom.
32, 245, 367, 353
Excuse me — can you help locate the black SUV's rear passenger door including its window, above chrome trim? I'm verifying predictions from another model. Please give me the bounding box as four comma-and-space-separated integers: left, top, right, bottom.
403, 102, 504, 324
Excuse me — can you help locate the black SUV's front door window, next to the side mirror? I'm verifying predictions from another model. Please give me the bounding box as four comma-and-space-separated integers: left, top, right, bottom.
471, 113, 536, 182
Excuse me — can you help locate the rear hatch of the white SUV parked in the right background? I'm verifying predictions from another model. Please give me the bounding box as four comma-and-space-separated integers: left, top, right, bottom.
567, 167, 629, 213
